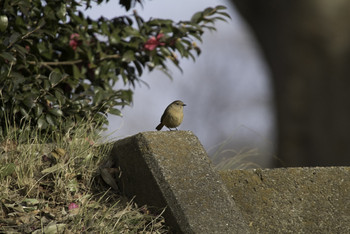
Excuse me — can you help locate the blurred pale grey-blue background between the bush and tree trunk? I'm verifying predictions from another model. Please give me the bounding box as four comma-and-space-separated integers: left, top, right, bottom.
85, 0, 275, 167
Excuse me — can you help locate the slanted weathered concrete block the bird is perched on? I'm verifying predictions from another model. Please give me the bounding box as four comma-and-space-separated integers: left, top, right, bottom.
111, 131, 249, 233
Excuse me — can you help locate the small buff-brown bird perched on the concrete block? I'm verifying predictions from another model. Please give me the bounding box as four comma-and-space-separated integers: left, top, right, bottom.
156, 100, 186, 131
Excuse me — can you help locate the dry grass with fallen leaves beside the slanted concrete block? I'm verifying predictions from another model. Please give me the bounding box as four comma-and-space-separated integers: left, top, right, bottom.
0, 123, 167, 233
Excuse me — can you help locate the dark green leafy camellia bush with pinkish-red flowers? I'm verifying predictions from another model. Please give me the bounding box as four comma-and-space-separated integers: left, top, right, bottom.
0, 0, 229, 137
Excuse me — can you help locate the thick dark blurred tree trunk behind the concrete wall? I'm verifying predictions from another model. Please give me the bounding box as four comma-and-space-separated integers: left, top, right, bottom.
232, 0, 350, 166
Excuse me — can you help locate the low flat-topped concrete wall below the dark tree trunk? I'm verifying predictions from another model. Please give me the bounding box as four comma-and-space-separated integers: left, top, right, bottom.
220, 167, 350, 233
